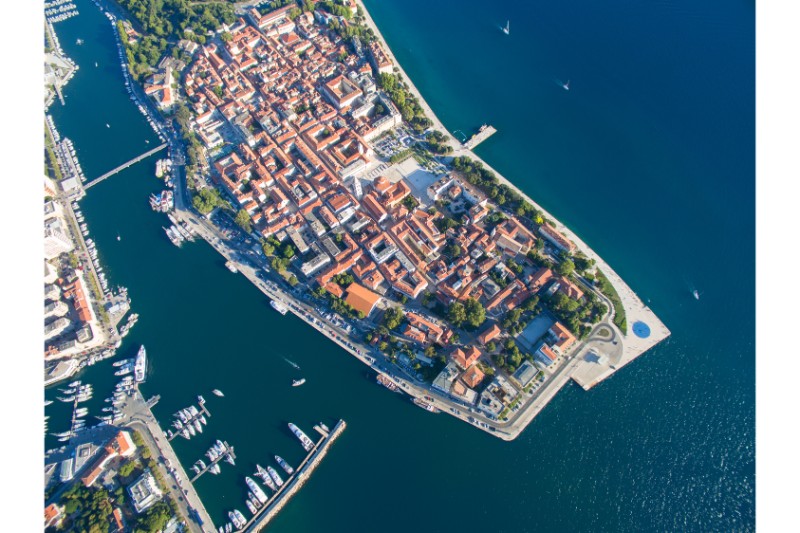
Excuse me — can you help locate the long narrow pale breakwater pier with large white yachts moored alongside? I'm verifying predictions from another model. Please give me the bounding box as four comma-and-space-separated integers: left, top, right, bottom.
241, 420, 347, 533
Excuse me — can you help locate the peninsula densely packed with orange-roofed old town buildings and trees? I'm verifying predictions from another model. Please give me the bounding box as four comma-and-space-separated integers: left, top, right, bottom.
117, 0, 669, 440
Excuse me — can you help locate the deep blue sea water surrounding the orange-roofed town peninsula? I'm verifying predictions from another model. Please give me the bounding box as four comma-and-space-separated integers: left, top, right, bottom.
48, 0, 755, 532
